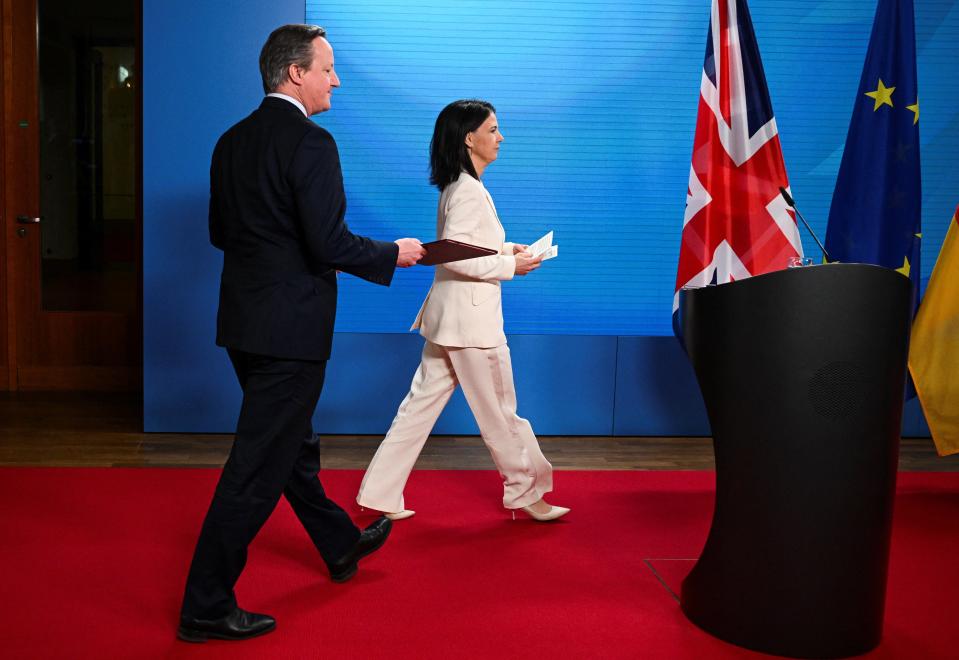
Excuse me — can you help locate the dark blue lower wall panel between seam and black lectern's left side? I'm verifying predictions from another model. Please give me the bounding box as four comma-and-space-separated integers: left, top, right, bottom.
613, 337, 710, 436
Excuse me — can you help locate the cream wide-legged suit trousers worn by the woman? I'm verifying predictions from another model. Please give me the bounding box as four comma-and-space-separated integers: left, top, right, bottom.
356, 341, 553, 512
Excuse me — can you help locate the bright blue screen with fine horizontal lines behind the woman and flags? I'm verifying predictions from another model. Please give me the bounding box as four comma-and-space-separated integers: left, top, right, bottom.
306, 0, 959, 335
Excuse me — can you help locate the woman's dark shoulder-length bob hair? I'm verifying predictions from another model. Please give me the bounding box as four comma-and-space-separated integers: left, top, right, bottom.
430, 99, 496, 191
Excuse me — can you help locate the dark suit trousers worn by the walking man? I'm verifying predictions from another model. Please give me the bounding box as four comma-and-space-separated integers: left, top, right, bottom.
181, 349, 360, 619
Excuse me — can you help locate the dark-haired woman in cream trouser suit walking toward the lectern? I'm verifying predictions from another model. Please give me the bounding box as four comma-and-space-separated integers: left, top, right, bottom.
356, 100, 569, 521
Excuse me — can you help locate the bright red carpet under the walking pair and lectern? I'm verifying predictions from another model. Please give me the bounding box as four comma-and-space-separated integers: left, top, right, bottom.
0, 468, 959, 660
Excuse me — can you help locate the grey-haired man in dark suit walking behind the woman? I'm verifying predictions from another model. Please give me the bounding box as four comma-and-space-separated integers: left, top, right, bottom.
177, 25, 424, 642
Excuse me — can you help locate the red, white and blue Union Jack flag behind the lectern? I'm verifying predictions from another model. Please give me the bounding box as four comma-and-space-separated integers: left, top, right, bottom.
673, 0, 802, 326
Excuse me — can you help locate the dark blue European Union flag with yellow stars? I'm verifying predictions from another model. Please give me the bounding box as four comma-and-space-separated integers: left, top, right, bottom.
826, 0, 922, 301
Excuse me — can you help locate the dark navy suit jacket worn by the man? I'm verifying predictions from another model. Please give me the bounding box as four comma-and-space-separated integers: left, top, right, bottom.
210, 97, 399, 360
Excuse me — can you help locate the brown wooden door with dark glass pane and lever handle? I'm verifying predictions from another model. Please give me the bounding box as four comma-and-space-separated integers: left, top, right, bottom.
0, 0, 142, 390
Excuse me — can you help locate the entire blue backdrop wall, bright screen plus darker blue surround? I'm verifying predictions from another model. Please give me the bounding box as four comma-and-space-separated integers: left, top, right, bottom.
142, 0, 959, 435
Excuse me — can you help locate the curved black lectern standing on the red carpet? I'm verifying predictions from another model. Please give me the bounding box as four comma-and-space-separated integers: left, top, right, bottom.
680, 264, 912, 658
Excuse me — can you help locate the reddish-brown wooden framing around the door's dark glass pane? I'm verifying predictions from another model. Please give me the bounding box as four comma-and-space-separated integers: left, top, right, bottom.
0, 0, 143, 391
